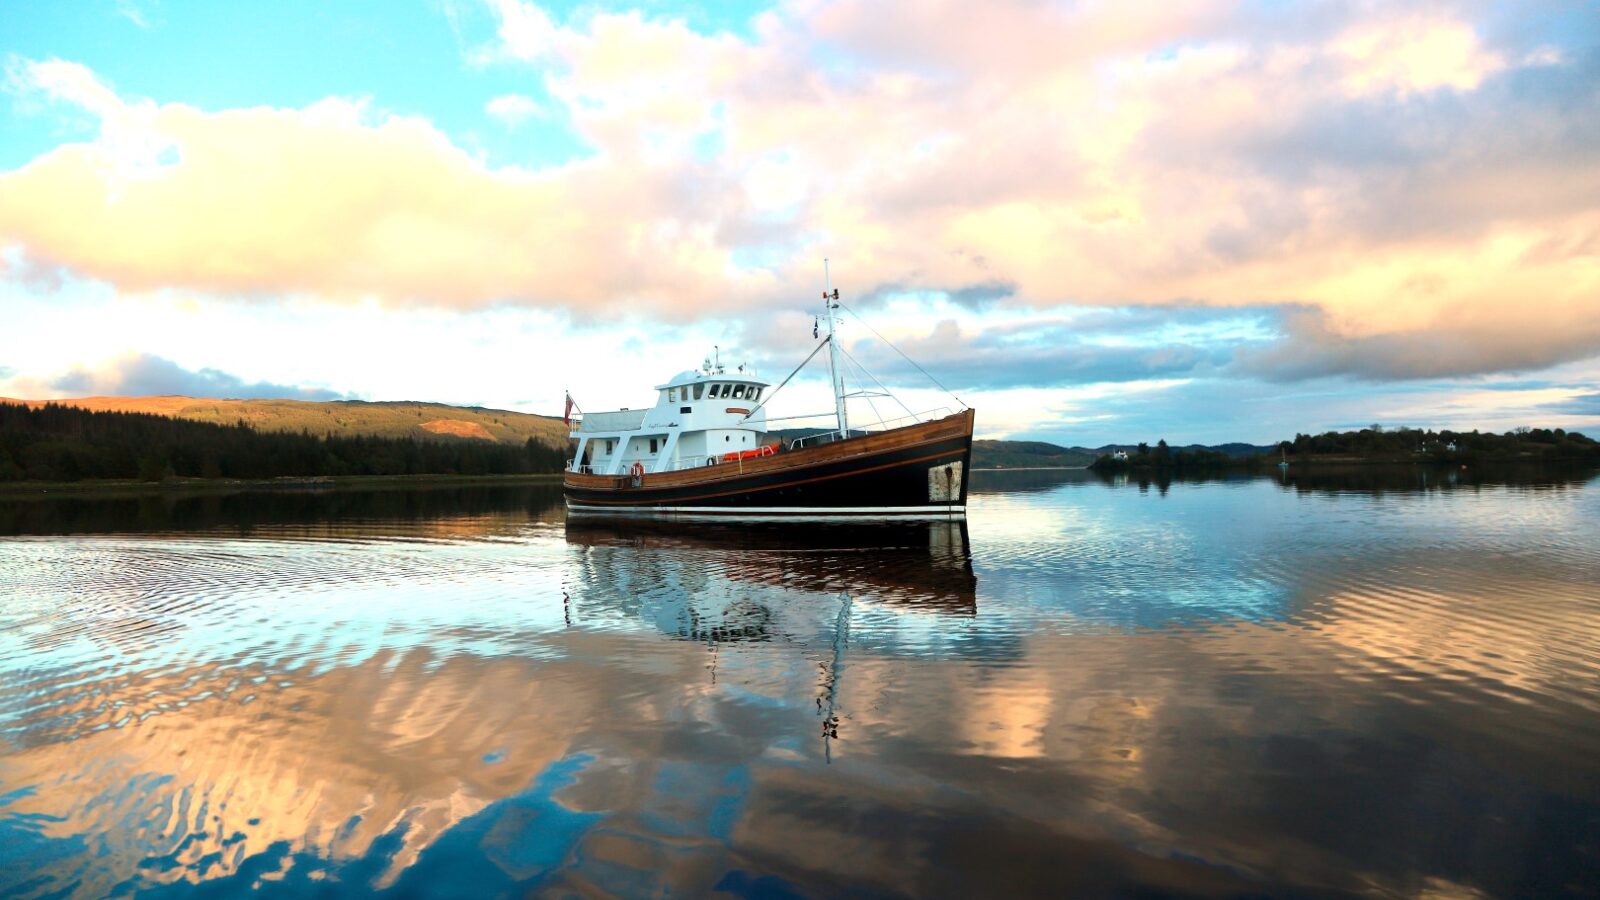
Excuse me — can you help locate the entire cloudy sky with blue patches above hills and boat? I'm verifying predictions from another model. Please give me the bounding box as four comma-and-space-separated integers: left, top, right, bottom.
0, 0, 1600, 447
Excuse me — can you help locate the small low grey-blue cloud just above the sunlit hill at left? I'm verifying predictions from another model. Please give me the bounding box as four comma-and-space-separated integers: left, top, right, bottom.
50, 354, 349, 400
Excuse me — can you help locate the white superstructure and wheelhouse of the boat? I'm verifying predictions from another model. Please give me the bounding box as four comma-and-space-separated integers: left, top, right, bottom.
573, 362, 770, 476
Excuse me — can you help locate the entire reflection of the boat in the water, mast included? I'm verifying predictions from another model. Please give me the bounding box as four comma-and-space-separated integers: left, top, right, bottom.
566, 519, 978, 762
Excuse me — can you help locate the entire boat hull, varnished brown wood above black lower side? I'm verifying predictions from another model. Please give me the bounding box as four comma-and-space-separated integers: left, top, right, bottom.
563, 410, 973, 519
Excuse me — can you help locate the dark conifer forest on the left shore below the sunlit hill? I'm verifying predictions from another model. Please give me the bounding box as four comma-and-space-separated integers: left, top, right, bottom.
0, 404, 566, 482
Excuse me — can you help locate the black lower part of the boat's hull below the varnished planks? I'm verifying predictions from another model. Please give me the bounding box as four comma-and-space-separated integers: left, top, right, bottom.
565, 434, 971, 519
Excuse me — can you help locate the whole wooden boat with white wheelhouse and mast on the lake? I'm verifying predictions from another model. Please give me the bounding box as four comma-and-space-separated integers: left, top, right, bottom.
562, 265, 974, 520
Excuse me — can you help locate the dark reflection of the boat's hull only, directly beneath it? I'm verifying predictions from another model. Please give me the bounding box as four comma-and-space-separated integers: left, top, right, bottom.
566, 519, 978, 617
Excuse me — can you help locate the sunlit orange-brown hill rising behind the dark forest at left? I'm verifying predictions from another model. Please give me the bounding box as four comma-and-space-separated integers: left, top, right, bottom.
0, 397, 566, 448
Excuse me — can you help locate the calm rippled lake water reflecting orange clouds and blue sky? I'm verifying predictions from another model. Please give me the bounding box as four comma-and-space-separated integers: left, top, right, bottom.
0, 469, 1600, 897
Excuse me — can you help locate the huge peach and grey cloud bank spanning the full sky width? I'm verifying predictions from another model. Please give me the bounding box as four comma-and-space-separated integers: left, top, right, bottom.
0, 0, 1600, 378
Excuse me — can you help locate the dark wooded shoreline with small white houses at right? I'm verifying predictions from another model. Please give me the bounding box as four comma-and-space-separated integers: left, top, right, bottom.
1090, 424, 1600, 472
